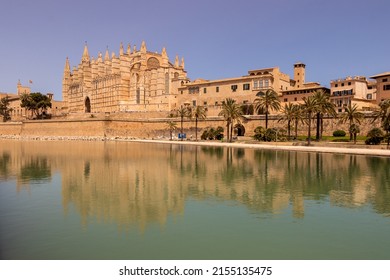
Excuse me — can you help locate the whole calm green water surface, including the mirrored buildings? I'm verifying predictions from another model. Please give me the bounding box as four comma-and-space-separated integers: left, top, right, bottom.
0, 140, 390, 260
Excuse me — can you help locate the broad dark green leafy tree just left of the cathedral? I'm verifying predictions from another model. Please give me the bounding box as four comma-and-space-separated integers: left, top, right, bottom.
20, 92, 51, 118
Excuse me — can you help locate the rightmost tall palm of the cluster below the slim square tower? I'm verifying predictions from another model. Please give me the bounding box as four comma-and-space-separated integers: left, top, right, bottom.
313, 89, 337, 141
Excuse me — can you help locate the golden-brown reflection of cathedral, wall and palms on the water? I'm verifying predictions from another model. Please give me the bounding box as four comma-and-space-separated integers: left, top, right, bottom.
0, 140, 390, 229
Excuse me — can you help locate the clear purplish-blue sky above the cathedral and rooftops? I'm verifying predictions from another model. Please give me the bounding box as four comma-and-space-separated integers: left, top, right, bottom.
0, 0, 390, 100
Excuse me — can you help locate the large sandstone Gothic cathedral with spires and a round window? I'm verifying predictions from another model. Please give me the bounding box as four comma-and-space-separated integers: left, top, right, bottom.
62, 42, 188, 113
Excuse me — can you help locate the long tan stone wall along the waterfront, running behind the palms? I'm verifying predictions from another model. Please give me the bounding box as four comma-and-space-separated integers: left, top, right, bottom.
0, 113, 380, 139
